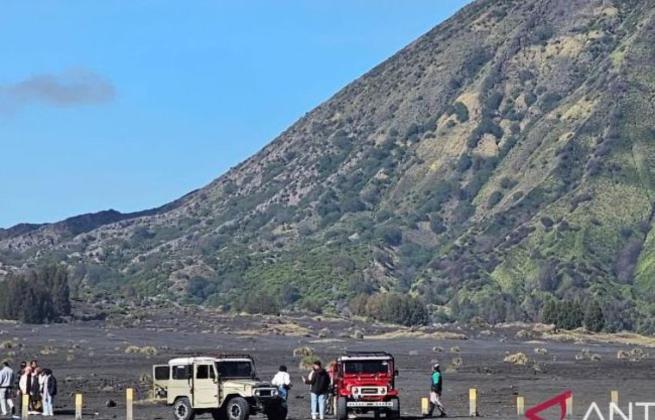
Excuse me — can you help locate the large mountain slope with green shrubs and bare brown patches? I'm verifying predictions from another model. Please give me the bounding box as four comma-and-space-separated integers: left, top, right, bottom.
0, 0, 655, 330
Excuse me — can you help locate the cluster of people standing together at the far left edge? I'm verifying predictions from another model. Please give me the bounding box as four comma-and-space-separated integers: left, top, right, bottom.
0, 360, 57, 416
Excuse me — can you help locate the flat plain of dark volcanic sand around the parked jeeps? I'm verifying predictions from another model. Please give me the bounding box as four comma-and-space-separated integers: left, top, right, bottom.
0, 317, 655, 419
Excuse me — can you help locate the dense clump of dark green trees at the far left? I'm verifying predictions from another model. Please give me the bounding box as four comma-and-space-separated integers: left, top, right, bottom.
0, 265, 71, 324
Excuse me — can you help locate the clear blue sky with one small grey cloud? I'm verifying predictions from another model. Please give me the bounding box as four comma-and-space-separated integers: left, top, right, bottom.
0, 0, 469, 227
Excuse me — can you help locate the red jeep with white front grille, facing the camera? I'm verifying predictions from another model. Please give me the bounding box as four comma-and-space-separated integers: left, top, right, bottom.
333, 352, 400, 420
